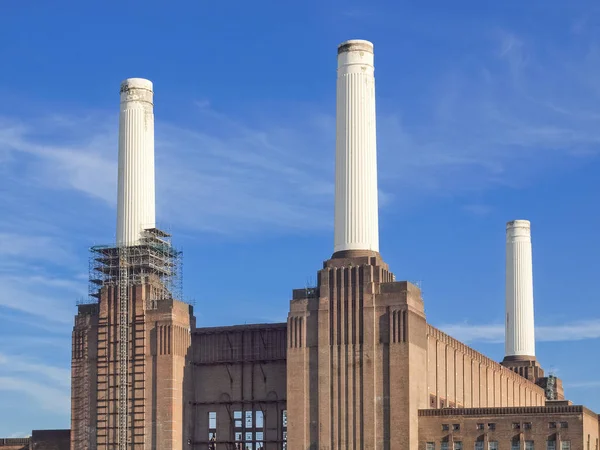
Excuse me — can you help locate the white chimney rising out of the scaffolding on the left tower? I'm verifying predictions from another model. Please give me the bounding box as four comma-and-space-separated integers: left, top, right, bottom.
117, 78, 156, 247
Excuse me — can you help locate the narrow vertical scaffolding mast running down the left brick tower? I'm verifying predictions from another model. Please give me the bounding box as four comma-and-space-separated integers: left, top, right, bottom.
118, 246, 130, 450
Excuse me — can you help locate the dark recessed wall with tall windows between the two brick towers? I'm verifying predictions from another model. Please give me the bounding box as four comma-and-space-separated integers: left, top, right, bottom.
191, 324, 287, 450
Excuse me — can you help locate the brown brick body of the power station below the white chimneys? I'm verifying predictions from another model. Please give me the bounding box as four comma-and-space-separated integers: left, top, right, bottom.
63, 252, 600, 450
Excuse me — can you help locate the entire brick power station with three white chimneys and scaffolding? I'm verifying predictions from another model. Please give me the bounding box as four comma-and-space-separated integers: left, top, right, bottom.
0, 40, 600, 450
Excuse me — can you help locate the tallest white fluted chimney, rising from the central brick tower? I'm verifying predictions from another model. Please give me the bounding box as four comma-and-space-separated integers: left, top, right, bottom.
334, 40, 379, 253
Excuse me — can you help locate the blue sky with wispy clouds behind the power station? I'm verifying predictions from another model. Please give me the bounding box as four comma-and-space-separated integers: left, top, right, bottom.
0, 0, 600, 436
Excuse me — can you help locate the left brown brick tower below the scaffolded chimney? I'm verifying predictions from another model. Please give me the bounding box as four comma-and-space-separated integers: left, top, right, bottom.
71, 283, 195, 450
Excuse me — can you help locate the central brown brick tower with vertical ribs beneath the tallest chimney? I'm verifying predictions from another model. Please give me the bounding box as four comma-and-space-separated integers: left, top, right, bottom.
287, 254, 427, 450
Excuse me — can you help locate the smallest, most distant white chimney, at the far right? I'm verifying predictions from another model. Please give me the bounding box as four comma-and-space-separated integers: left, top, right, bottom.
505, 220, 535, 359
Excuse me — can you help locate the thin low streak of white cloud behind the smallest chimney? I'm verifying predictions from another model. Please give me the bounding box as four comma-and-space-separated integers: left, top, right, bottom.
439, 319, 600, 344
